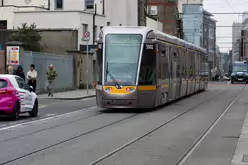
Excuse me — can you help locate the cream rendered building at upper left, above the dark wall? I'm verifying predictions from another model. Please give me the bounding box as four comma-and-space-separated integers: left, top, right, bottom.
0, 0, 160, 51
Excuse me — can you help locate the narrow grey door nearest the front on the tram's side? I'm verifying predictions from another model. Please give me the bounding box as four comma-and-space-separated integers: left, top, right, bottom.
169, 48, 177, 100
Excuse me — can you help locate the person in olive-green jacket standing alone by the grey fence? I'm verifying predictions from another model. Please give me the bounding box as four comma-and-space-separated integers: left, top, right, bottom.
46, 64, 57, 97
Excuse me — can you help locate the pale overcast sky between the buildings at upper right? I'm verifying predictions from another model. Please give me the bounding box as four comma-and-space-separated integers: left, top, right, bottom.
203, 0, 248, 52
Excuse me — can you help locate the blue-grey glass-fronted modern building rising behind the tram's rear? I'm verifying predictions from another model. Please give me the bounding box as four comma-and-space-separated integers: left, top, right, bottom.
178, 0, 216, 76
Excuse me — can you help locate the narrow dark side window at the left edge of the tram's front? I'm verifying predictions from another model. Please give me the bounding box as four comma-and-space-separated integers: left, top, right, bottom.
96, 44, 103, 85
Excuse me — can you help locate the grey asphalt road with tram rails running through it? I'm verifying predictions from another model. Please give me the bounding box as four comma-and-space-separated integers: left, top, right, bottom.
0, 83, 248, 165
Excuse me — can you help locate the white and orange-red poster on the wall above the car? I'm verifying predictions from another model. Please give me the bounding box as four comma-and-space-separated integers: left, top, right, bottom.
6, 46, 20, 65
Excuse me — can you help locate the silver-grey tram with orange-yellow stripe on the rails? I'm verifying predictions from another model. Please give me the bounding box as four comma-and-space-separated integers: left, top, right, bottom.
96, 26, 208, 108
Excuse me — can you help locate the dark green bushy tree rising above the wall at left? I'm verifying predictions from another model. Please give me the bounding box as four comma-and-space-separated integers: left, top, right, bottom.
10, 23, 43, 51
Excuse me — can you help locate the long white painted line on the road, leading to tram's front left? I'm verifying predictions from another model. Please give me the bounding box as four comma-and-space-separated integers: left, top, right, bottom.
0, 106, 97, 131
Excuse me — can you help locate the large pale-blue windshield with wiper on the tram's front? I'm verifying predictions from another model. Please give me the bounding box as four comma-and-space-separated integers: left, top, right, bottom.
104, 34, 142, 85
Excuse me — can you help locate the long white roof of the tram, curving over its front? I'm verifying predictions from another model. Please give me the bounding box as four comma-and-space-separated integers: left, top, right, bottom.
102, 26, 206, 53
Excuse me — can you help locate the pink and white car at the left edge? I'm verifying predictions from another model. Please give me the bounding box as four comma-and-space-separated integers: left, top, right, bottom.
0, 74, 38, 120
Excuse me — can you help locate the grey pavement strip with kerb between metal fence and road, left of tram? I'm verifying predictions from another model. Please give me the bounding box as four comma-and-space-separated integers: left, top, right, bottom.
39, 89, 96, 100
